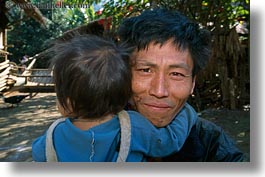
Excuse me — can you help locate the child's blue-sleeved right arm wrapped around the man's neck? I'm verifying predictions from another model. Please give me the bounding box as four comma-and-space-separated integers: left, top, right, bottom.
131, 104, 197, 157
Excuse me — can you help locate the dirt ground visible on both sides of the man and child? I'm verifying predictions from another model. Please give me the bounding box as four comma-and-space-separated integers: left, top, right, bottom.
0, 93, 250, 162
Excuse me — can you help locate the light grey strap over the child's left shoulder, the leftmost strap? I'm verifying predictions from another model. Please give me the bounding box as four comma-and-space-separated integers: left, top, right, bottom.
45, 118, 66, 162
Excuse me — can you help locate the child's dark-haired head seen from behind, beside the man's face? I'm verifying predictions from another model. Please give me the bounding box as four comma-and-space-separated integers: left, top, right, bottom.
49, 35, 131, 118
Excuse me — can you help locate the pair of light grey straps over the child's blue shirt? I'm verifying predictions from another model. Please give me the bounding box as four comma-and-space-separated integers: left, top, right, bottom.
45, 110, 131, 162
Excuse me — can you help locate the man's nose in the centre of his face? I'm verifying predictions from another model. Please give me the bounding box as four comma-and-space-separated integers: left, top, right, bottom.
149, 74, 169, 98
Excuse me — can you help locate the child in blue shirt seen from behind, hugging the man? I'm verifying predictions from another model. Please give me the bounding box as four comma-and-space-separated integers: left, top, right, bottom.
32, 35, 197, 162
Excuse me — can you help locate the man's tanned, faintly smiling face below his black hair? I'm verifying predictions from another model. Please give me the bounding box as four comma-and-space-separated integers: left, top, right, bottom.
132, 41, 195, 127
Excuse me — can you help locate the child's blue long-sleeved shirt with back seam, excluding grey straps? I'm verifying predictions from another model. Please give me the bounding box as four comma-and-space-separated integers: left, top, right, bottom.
32, 104, 197, 162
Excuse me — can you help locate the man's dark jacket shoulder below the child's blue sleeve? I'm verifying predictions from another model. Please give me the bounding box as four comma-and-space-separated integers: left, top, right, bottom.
160, 118, 243, 162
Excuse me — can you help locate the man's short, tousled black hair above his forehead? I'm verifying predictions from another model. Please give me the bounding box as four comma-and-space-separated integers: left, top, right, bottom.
118, 8, 211, 75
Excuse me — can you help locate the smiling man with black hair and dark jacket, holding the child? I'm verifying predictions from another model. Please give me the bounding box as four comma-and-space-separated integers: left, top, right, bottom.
118, 9, 244, 162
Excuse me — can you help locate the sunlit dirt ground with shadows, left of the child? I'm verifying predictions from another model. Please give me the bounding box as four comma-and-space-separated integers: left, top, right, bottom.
0, 93, 60, 162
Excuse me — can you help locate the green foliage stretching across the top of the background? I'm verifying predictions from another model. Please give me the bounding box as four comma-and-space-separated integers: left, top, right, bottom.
8, 0, 249, 68
